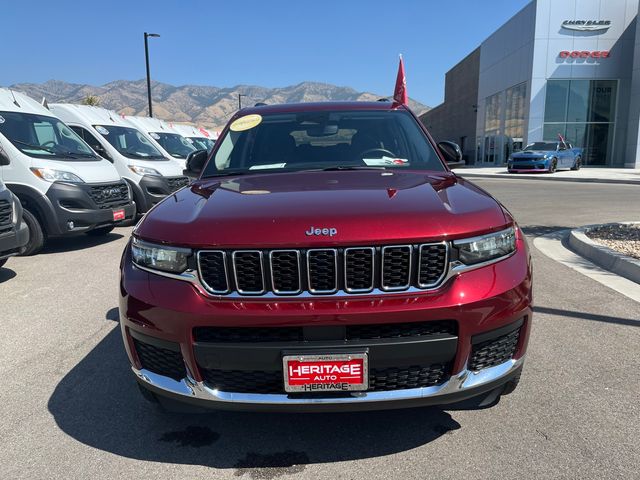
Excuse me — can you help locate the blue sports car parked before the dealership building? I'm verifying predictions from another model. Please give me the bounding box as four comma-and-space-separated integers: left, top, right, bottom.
507, 139, 582, 173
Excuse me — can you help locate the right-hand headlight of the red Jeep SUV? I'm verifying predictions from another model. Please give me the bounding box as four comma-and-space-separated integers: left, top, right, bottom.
453, 227, 516, 265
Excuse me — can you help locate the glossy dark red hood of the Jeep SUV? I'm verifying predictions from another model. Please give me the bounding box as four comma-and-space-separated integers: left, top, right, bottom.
135, 170, 508, 248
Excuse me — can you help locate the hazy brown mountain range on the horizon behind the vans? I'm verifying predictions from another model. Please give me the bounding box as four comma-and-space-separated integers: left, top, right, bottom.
9, 79, 429, 128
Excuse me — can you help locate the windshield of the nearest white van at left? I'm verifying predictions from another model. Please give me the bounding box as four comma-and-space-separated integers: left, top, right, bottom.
0, 112, 100, 161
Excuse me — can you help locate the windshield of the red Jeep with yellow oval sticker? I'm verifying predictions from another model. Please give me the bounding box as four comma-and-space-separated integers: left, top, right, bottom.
203, 110, 444, 177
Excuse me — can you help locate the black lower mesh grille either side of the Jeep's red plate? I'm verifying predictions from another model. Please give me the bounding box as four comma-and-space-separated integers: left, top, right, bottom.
202, 364, 449, 394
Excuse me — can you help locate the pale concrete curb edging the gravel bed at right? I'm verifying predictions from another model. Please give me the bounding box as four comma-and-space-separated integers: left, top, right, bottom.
569, 222, 640, 284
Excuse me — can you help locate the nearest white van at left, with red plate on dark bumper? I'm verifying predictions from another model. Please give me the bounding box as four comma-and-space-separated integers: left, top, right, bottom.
0, 88, 135, 255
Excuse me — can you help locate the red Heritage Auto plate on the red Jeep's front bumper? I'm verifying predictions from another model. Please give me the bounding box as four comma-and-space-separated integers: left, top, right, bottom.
282, 353, 369, 393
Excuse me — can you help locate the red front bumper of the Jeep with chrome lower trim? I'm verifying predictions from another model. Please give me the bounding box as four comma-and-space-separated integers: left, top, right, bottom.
120, 237, 532, 411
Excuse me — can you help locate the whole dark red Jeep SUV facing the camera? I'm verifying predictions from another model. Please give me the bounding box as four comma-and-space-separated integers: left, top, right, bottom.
120, 102, 532, 411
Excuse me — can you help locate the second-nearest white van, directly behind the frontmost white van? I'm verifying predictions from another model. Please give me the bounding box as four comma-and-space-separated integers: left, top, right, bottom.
49, 103, 189, 219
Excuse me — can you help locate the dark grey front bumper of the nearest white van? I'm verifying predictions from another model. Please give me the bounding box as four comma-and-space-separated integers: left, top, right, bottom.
46, 181, 136, 235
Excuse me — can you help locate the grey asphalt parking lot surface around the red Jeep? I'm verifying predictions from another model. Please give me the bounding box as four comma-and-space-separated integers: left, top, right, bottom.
0, 178, 640, 479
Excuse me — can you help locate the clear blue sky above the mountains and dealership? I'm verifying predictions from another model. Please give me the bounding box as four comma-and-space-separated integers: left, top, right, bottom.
0, 0, 529, 106
